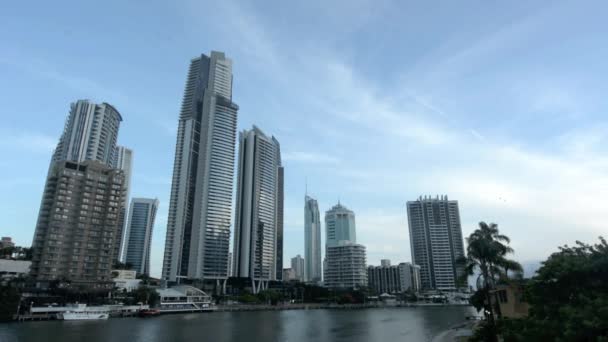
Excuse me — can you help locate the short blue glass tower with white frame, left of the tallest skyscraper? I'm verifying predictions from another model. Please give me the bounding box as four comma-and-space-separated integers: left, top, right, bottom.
124, 198, 158, 275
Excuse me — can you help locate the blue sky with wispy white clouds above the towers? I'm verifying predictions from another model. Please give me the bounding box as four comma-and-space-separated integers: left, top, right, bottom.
0, 0, 608, 276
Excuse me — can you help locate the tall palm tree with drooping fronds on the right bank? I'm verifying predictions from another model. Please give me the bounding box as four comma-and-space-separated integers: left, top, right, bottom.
461, 222, 522, 340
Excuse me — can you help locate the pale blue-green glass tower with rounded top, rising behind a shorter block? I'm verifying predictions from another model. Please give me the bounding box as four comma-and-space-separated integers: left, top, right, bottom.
325, 203, 357, 247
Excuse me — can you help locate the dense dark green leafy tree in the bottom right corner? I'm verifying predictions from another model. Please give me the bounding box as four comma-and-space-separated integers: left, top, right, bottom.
500, 237, 608, 341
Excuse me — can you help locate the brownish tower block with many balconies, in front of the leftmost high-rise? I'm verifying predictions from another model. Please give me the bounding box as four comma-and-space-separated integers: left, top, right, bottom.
31, 160, 125, 287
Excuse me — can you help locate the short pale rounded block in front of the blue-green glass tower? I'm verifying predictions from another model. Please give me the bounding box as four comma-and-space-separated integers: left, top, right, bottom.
323, 241, 367, 289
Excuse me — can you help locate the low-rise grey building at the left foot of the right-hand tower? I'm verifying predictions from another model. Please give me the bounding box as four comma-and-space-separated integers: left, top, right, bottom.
367, 259, 420, 294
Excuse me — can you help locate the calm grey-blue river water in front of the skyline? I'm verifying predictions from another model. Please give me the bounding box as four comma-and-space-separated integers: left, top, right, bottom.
0, 307, 473, 342
